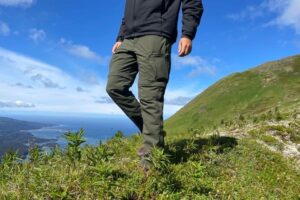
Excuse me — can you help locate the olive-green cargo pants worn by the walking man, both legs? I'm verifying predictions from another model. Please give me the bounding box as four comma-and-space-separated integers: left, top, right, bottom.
106, 35, 172, 153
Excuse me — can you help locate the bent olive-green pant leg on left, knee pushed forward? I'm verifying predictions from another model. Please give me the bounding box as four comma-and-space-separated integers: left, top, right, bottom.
106, 39, 143, 132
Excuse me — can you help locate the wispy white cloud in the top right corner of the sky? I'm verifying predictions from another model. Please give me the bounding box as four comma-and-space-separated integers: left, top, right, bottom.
227, 0, 300, 34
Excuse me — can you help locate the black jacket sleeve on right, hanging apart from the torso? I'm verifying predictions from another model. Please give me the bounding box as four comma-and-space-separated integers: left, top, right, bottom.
181, 0, 204, 40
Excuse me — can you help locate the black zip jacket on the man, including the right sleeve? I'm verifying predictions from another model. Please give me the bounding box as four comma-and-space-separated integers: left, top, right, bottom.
116, 0, 203, 43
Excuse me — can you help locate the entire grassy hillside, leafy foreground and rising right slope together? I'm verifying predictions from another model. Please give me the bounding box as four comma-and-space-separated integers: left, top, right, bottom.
0, 56, 300, 200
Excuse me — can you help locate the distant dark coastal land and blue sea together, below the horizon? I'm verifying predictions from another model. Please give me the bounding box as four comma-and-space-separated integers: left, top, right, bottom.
0, 115, 138, 156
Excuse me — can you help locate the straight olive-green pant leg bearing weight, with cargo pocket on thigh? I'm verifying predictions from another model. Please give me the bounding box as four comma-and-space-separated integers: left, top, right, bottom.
134, 35, 171, 153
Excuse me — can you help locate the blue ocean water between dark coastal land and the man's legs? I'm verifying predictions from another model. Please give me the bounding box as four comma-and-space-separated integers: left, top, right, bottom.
1, 115, 139, 146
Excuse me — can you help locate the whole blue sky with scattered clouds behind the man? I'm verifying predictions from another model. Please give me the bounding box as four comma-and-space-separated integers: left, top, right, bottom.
0, 0, 300, 117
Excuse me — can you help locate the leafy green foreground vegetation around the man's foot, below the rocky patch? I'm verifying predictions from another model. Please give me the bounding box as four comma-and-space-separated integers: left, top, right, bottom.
0, 129, 300, 199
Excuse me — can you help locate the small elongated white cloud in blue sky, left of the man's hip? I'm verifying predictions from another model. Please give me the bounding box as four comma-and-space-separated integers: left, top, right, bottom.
59, 38, 109, 65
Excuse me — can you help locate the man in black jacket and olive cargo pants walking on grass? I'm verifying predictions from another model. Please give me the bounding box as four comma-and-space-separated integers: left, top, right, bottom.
106, 0, 203, 168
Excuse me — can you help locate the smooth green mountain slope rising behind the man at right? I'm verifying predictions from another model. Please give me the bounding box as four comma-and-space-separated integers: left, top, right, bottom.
165, 55, 300, 132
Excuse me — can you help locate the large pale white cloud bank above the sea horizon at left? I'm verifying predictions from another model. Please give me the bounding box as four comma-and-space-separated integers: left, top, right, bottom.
0, 47, 123, 114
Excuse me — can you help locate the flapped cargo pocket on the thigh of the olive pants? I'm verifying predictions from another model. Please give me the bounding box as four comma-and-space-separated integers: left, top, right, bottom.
150, 52, 171, 85
